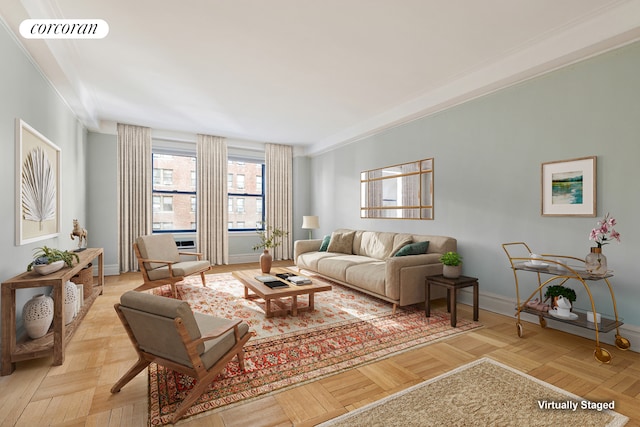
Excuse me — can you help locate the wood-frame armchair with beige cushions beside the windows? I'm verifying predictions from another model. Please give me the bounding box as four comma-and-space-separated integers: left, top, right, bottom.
133, 234, 211, 298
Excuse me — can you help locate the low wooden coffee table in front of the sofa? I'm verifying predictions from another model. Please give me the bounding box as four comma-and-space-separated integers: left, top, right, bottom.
233, 268, 331, 317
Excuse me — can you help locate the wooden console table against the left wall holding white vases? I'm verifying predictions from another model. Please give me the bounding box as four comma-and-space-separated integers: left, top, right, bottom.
0, 248, 104, 376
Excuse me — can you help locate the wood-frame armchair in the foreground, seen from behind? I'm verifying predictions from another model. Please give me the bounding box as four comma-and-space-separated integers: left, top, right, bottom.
111, 291, 253, 423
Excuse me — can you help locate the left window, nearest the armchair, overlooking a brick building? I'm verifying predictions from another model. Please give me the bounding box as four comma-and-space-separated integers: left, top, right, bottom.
152, 151, 197, 232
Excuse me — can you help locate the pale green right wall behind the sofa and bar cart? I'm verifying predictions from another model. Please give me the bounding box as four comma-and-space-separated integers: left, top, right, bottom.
310, 43, 640, 325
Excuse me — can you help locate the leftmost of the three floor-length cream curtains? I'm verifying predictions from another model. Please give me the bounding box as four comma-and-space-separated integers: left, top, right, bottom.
117, 123, 153, 273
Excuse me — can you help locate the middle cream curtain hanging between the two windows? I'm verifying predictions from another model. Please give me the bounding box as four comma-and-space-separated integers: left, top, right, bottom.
197, 135, 229, 265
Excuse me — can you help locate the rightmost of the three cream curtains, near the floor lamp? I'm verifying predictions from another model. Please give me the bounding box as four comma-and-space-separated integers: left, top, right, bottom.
265, 144, 293, 259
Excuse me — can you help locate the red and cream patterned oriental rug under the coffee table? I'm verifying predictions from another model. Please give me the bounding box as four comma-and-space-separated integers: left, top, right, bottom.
149, 273, 481, 425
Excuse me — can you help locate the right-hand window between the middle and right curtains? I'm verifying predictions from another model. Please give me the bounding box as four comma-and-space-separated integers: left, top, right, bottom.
227, 158, 264, 231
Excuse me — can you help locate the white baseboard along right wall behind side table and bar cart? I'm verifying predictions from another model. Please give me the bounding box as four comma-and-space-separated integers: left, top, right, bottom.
457, 289, 640, 356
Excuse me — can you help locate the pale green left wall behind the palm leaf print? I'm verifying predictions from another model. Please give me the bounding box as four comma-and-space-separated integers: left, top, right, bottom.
0, 20, 87, 342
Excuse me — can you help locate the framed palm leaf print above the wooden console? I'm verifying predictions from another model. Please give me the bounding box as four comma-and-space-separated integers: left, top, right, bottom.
15, 119, 60, 245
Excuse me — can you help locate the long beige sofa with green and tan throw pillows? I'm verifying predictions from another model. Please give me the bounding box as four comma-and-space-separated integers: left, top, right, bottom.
294, 229, 457, 310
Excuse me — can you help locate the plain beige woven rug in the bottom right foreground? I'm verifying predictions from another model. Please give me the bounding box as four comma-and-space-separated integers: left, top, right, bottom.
319, 358, 628, 427
